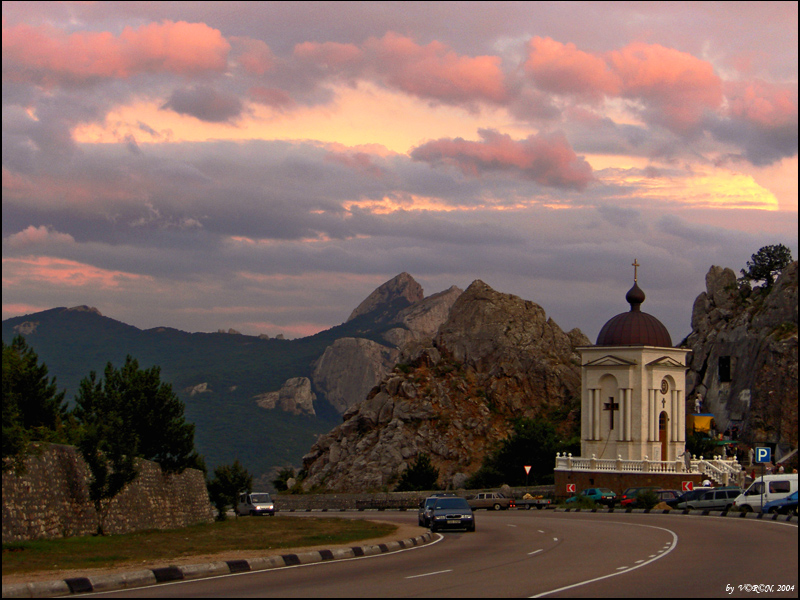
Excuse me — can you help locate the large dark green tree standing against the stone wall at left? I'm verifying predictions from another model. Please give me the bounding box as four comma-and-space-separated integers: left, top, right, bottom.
73, 356, 201, 533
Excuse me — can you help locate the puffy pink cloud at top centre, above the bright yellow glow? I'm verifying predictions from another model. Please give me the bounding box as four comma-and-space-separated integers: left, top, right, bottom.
364, 32, 507, 103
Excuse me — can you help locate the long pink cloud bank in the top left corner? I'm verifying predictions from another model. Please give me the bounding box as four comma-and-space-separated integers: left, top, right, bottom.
3, 21, 230, 85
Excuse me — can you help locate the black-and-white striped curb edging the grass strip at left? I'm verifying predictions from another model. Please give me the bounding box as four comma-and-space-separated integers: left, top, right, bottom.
3, 532, 433, 598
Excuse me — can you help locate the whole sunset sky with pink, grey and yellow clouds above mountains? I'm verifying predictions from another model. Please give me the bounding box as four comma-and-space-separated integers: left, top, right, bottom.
2, 2, 798, 344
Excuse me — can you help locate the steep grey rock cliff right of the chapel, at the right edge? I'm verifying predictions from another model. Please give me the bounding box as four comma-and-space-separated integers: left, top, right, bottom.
683, 261, 797, 456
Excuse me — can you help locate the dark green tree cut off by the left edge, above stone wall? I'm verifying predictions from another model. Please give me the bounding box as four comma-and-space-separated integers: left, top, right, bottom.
3, 335, 69, 471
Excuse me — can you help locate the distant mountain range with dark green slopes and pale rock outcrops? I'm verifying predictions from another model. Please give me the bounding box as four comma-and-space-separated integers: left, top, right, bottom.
2, 273, 461, 481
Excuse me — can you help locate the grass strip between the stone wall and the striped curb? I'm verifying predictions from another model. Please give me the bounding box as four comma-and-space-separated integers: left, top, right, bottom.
3, 517, 397, 575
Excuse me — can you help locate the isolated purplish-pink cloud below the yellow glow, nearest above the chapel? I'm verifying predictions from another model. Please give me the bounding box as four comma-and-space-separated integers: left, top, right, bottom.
411, 129, 593, 190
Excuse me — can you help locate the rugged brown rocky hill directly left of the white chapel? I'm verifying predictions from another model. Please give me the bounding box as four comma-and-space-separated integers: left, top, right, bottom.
302, 281, 590, 491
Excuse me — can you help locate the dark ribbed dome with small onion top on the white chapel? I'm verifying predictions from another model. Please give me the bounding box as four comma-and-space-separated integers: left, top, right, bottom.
597, 283, 672, 348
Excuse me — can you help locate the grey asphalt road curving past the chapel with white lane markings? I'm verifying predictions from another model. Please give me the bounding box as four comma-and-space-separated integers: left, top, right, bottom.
90, 511, 798, 598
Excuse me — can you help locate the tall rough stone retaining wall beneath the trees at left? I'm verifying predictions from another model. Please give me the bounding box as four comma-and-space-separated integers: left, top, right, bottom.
3, 444, 213, 543
